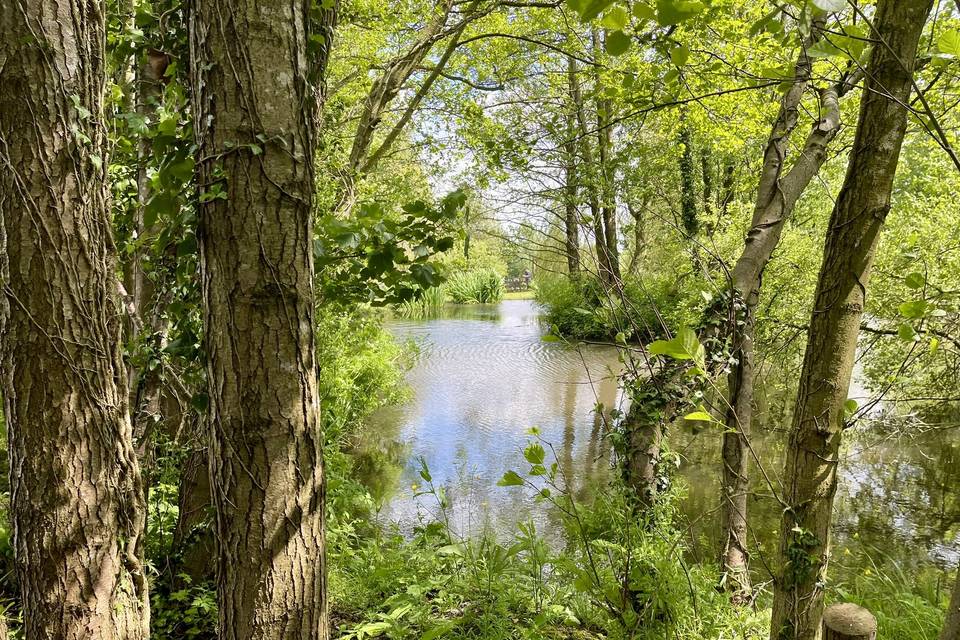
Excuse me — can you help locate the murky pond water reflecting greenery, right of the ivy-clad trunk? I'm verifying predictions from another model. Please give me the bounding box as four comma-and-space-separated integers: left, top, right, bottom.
673, 428, 960, 580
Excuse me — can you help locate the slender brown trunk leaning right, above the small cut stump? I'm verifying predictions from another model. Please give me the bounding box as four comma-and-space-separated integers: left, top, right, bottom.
770, 0, 933, 640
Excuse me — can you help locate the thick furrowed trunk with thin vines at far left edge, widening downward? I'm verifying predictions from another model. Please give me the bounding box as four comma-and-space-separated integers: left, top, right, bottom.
0, 0, 149, 640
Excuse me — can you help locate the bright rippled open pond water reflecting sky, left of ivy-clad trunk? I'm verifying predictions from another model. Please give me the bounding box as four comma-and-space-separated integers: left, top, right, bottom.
373, 300, 618, 532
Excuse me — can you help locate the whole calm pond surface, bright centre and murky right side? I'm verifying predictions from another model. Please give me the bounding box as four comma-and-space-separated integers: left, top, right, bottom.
366, 300, 960, 575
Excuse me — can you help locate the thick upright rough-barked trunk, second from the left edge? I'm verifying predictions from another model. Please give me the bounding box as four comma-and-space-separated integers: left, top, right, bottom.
190, 0, 329, 640
